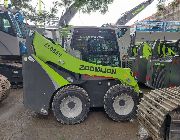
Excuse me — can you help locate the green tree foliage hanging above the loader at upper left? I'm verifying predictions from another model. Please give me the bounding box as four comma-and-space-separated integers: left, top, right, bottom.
12, 0, 114, 23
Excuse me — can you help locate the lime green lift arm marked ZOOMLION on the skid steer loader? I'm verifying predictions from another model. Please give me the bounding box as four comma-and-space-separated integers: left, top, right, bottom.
33, 32, 139, 92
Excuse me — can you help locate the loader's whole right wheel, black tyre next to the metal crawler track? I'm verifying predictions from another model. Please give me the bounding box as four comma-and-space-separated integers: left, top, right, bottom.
104, 84, 139, 122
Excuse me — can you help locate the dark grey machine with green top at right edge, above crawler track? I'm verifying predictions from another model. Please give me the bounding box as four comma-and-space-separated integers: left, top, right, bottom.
146, 40, 180, 89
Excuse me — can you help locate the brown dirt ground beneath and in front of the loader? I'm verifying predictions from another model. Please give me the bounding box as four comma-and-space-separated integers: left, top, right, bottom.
0, 90, 145, 140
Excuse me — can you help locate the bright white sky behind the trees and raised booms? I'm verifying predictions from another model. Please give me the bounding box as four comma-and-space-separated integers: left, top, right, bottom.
0, 0, 173, 26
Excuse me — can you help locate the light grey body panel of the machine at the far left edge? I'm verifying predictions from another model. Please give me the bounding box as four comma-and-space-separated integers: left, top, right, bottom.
0, 31, 20, 55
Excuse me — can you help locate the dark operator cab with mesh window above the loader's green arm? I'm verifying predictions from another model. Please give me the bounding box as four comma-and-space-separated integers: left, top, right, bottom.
70, 27, 129, 67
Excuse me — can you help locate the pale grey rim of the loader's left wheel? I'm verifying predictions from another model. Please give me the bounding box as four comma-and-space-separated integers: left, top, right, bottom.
60, 96, 82, 118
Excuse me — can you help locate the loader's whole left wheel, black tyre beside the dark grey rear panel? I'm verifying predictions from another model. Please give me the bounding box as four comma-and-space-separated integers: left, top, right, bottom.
52, 85, 90, 124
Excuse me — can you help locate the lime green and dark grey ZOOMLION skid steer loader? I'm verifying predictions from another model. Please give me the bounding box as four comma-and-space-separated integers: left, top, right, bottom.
23, 28, 141, 124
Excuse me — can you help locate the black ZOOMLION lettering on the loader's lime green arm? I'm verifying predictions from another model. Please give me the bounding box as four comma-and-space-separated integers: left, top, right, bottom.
79, 65, 116, 74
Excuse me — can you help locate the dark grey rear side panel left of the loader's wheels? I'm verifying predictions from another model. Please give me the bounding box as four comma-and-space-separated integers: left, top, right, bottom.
23, 57, 56, 115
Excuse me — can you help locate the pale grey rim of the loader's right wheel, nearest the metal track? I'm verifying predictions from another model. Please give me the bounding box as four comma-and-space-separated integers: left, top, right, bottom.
113, 94, 134, 115
